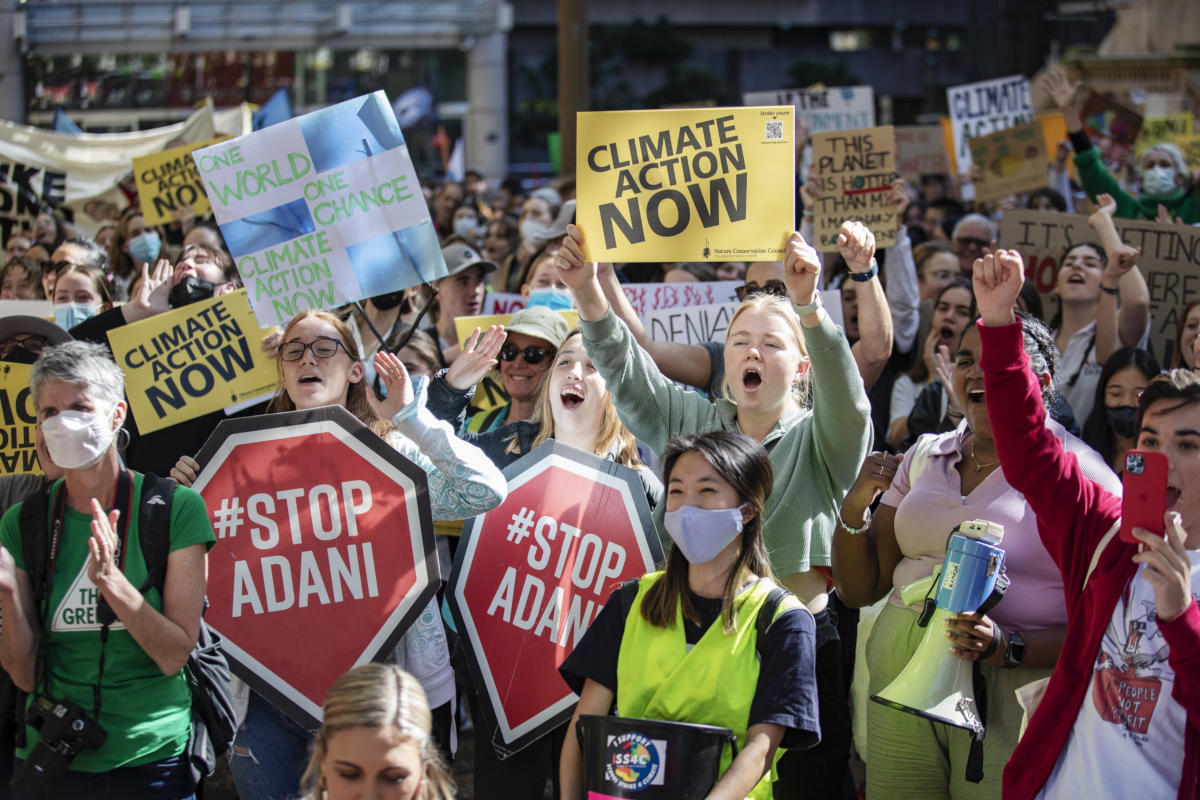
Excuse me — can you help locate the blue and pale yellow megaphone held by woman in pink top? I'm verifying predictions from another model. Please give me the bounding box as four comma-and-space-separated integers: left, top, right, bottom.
871, 519, 1008, 741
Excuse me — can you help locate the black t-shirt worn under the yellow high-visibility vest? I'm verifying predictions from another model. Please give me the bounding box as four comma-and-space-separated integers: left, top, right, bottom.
558, 589, 821, 750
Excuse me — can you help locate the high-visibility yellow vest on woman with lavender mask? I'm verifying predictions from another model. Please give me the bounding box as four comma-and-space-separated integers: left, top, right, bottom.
617, 572, 799, 800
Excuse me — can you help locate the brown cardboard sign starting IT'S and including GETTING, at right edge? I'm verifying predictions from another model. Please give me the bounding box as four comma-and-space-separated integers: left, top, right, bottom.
1000, 211, 1200, 365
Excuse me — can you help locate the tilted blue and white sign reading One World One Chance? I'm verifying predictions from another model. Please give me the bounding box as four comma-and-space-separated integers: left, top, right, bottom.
192, 91, 446, 325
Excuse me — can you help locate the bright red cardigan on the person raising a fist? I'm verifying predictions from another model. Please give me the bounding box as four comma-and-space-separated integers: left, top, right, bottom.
979, 324, 1200, 800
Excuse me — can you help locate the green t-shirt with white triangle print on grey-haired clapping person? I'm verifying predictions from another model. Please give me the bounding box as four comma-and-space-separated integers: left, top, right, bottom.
0, 473, 216, 772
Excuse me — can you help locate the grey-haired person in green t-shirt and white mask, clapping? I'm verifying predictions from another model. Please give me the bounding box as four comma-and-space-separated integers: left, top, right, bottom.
0, 342, 216, 800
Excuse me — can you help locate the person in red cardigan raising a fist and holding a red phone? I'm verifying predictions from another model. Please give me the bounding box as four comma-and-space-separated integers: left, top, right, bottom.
973, 251, 1200, 800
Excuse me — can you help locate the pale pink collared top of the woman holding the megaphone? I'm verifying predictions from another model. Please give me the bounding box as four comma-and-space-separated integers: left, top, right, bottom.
883, 417, 1121, 631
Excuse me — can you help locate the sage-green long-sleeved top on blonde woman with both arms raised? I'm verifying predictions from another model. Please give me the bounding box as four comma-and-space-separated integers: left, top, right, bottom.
581, 309, 871, 577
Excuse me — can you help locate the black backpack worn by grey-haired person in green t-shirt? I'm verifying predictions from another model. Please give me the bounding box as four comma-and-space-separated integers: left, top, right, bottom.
17, 473, 238, 781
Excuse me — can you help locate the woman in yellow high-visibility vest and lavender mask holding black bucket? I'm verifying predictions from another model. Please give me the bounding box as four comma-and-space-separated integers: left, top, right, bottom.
559, 431, 821, 800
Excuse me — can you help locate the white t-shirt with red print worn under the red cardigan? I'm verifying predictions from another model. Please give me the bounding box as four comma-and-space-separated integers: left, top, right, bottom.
1038, 551, 1200, 800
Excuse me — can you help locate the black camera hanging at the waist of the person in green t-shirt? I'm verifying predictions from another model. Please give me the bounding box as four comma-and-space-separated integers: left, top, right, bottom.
12, 694, 108, 789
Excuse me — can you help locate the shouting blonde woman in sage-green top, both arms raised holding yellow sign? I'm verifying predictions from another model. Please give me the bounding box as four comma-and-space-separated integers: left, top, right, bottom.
556, 222, 876, 796
